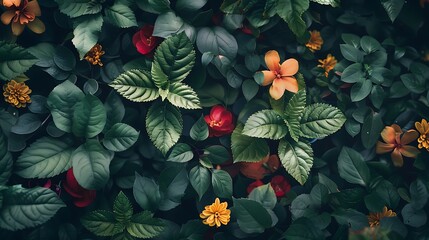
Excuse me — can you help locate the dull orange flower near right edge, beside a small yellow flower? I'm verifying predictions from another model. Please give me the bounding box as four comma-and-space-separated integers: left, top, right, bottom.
375, 124, 419, 167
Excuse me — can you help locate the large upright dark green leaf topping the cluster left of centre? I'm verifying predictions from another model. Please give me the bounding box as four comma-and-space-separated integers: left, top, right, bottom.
151, 32, 195, 89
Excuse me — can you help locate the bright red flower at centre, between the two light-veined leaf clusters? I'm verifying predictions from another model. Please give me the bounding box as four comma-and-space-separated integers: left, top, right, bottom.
204, 105, 235, 137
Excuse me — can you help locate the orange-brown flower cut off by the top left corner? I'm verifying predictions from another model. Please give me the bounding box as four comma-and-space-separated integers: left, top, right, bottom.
1, 0, 45, 36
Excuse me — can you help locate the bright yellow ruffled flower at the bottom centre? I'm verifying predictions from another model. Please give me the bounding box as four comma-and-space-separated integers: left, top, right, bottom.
200, 198, 231, 227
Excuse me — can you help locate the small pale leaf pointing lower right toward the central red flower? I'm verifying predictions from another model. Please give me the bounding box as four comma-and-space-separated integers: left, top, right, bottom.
167, 82, 201, 109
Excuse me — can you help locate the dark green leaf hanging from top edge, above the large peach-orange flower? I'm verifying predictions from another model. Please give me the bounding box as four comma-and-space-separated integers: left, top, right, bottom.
277, 0, 310, 37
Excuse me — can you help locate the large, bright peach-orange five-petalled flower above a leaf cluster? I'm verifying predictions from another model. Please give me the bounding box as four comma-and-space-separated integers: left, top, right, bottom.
262, 50, 299, 100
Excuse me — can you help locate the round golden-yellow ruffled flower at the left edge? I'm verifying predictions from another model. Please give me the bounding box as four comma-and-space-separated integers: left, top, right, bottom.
3, 80, 31, 108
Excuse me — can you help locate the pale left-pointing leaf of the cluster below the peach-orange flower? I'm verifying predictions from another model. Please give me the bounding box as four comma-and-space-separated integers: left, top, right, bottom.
242, 110, 288, 140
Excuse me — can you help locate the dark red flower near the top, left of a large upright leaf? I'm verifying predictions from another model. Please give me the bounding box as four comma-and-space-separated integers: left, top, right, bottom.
133, 25, 161, 55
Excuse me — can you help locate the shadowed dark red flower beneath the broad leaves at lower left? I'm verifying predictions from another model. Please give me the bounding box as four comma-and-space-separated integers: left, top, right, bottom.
63, 168, 97, 207
